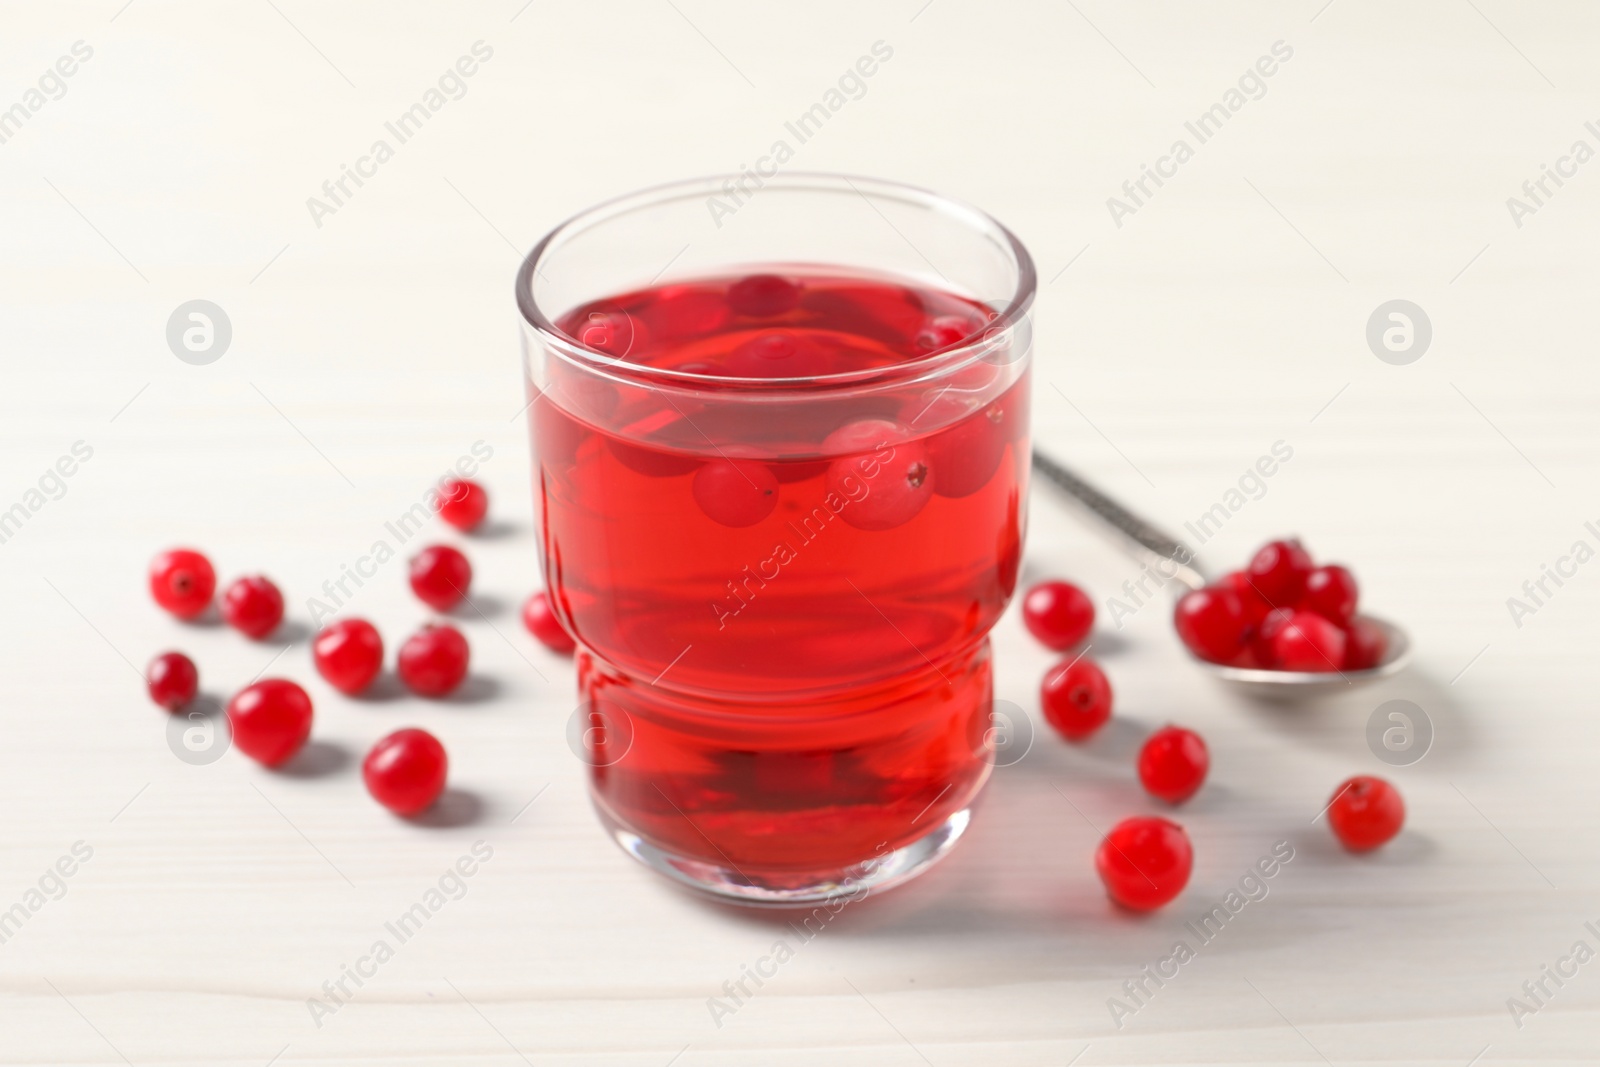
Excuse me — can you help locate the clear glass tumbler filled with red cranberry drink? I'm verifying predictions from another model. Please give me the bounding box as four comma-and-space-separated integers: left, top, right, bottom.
517, 173, 1035, 904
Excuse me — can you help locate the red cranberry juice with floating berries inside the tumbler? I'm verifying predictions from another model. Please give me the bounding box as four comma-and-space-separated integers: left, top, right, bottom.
533, 272, 1029, 878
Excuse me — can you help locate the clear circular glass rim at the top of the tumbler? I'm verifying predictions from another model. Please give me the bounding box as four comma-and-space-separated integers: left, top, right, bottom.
515, 171, 1038, 392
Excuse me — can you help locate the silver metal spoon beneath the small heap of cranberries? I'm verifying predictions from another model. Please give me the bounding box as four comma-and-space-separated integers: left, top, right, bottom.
1034, 451, 1411, 699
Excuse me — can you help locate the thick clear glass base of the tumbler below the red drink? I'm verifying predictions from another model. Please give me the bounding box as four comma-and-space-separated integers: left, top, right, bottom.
595, 803, 973, 907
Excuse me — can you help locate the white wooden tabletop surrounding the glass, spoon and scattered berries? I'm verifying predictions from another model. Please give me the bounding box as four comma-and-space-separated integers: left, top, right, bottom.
0, 0, 1600, 1067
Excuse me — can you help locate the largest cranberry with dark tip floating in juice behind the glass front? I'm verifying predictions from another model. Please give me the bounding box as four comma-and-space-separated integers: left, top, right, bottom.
822, 419, 934, 530
